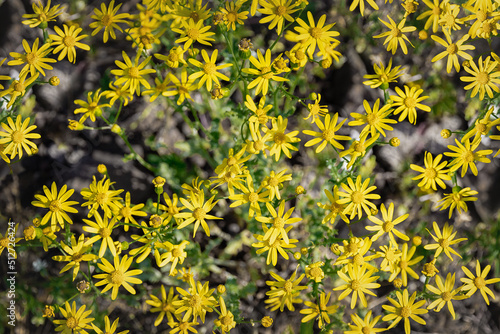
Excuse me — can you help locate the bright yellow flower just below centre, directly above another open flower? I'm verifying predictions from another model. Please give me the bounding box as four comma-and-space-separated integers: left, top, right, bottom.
255, 200, 302, 244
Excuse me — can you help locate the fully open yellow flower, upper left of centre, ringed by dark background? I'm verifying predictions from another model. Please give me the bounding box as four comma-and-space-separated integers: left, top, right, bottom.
189, 49, 233, 91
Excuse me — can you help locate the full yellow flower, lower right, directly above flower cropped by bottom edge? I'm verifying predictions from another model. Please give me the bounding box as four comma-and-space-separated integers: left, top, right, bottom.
333, 263, 380, 309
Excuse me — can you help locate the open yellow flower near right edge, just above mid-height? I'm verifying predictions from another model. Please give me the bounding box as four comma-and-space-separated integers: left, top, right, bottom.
444, 136, 492, 177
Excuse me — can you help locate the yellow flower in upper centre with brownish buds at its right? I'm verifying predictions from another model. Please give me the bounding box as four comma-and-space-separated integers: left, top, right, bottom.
242, 49, 288, 95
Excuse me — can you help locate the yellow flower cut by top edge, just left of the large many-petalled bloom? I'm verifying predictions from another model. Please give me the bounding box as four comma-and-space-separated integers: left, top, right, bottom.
260, 0, 299, 35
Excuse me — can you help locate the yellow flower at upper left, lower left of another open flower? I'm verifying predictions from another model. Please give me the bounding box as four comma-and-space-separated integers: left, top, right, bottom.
7, 38, 56, 77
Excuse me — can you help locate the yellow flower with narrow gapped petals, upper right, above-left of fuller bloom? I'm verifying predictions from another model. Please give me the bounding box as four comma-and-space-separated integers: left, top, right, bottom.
431, 30, 475, 73
